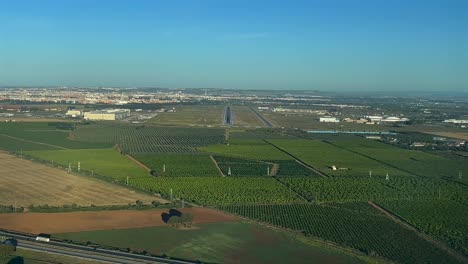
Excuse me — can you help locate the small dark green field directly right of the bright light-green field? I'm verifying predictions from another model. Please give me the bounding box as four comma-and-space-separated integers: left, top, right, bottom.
134, 154, 221, 177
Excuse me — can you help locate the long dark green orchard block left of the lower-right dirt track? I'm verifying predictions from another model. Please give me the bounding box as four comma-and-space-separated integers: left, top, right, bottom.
220, 204, 456, 263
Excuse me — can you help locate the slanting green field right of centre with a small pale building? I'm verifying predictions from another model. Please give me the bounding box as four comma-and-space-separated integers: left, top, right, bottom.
269, 139, 407, 178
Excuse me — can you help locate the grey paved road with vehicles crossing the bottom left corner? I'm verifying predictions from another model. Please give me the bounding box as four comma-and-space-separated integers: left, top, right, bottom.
0, 230, 197, 264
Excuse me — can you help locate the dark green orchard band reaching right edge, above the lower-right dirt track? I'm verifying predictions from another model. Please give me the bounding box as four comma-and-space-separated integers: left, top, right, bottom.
278, 177, 468, 204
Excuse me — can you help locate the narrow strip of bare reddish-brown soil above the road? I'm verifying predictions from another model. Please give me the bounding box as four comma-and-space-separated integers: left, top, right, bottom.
0, 208, 238, 234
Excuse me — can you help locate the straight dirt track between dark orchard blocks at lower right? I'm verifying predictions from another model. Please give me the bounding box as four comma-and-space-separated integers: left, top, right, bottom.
368, 201, 468, 263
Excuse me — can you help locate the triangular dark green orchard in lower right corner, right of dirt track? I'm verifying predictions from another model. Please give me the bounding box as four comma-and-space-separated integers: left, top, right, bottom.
379, 199, 468, 255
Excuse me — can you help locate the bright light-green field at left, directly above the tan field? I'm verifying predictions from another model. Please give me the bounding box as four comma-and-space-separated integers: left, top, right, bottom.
24, 149, 148, 180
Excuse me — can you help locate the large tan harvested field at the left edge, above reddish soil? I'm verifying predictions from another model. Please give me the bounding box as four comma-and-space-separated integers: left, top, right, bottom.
0, 152, 160, 207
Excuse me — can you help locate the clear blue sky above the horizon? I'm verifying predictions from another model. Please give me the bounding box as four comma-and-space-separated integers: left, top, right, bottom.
0, 0, 468, 91
